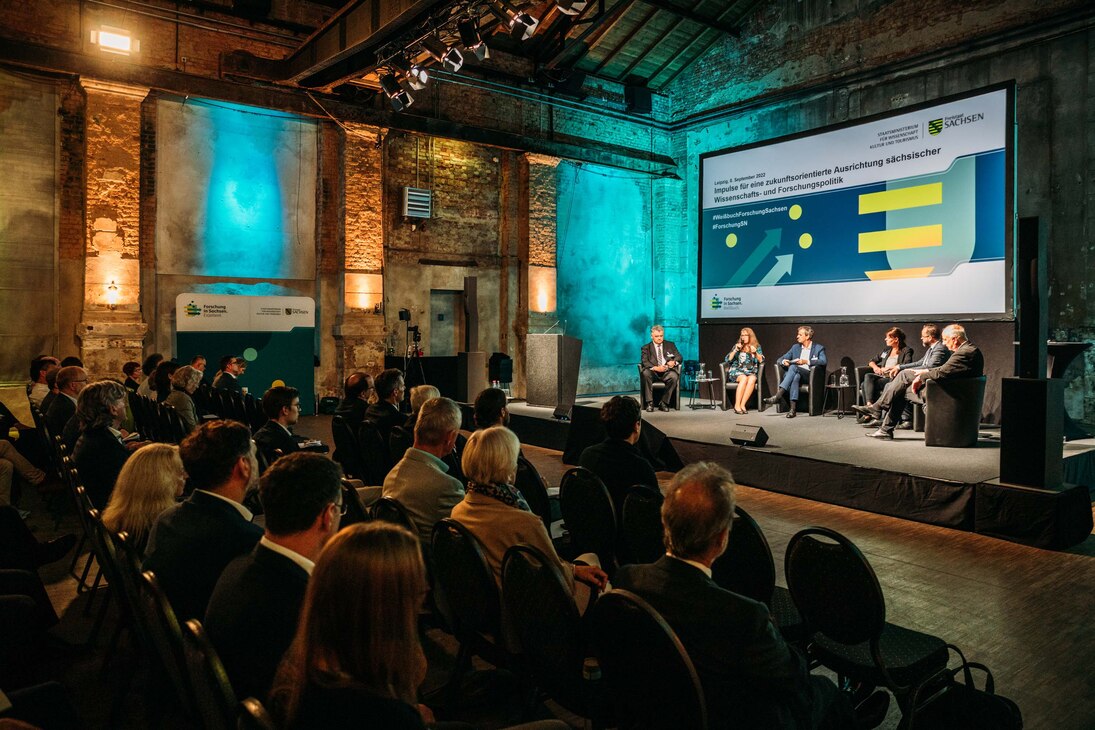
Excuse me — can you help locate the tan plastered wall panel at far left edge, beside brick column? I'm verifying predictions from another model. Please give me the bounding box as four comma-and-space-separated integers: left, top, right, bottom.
0, 71, 57, 382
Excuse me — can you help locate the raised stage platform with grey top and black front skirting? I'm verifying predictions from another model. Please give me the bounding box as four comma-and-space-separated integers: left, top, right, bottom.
509, 396, 1095, 549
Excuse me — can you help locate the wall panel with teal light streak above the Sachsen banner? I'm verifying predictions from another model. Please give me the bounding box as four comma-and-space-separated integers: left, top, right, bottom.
157, 99, 316, 279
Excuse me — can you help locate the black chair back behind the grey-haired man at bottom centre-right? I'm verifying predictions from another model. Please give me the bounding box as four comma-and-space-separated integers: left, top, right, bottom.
590, 590, 707, 729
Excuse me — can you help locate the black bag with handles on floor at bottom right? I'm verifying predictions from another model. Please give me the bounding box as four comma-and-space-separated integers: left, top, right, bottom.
907, 644, 1023, 730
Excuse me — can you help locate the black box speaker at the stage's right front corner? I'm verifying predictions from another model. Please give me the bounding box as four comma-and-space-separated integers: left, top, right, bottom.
1000, 378, 1064, 489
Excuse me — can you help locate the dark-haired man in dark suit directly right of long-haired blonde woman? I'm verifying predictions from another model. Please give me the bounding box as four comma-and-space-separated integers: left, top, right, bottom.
143, 420, 263, 622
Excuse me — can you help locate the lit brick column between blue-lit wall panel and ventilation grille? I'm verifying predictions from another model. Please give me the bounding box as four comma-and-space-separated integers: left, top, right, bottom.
335, 124, 388, 383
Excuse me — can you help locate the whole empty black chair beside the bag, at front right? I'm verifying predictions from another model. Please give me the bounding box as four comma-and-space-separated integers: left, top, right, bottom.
785, 528, 947, 722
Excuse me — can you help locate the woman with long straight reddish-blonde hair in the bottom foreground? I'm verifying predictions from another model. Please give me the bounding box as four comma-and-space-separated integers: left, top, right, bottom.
270, 522, 434, 730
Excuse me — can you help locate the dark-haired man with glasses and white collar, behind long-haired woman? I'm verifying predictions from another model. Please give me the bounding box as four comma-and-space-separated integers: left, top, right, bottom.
204, 452, 343, 697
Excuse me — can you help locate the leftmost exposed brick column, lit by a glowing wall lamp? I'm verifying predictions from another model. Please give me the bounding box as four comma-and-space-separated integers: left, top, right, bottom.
78, 79, 148, 378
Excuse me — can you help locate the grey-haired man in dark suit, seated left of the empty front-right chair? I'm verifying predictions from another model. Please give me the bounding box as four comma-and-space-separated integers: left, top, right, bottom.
612, 463, 888, 729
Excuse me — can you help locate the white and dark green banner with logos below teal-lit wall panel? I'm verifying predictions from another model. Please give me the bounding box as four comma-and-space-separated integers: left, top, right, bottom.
175, 292, 315, 414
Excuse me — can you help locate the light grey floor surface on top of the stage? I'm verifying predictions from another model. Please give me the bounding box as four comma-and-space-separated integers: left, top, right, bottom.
509, 396, 1095, 486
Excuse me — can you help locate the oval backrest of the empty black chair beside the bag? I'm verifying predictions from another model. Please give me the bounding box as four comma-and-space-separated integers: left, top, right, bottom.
784, 528, 886, 645
